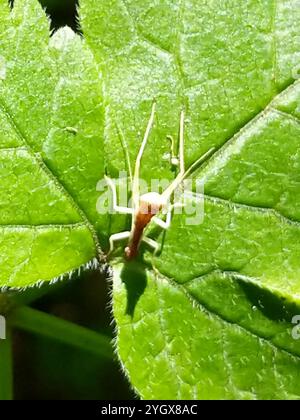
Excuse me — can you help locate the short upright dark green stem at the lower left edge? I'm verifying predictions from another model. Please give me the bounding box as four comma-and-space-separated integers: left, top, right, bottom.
0, 331, 13, 401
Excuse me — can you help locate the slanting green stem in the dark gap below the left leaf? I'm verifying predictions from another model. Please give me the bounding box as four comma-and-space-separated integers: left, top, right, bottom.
10, 306, 113, 359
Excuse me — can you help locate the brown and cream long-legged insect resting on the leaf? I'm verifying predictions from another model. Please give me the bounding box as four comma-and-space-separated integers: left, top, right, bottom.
105, 102, 214, 260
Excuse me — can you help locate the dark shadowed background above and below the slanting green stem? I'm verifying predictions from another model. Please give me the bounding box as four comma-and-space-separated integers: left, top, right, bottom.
13, 272, 133, 400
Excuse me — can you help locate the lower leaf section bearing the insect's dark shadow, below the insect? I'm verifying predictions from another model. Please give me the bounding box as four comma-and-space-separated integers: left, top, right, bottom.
114, 266, 300, 399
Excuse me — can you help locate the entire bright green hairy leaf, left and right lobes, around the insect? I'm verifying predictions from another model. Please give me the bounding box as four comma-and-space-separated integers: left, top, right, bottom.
0, 0, 300, 398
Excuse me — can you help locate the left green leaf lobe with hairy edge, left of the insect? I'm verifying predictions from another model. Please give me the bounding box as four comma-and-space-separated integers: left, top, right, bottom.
0, 0, 104, 287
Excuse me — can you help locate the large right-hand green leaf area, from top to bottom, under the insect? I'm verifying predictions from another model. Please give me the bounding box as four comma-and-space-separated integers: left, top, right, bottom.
80, 0, 300, 399
